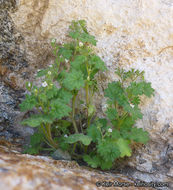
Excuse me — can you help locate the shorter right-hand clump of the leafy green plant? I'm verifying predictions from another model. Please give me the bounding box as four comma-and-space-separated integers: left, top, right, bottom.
84, 68, 154, 169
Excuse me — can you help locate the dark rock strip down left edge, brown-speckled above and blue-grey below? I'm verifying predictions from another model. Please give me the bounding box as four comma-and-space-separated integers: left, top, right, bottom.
0, 0, 27, 144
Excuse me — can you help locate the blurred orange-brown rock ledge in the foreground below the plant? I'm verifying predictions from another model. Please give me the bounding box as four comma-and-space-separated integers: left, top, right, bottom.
0, 146, 152, 190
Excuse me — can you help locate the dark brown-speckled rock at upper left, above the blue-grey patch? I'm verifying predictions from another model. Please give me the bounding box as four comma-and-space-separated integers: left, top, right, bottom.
0, 0, 27, 89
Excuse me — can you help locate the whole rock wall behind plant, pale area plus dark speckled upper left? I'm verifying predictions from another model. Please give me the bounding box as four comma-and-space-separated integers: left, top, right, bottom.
0, 0, 173, 189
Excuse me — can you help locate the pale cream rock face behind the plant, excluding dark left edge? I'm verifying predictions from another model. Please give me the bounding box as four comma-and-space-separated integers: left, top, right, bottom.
2, 0, 173, 187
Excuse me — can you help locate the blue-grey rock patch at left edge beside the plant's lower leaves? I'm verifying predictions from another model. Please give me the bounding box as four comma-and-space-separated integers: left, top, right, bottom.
0, 82, 33, 140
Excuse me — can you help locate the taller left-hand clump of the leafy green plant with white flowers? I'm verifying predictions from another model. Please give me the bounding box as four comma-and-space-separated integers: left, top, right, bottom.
20, 20, 106, 149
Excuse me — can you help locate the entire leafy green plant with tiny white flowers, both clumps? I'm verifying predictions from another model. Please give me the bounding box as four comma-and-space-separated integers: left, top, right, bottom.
20, 20, 153, 169
